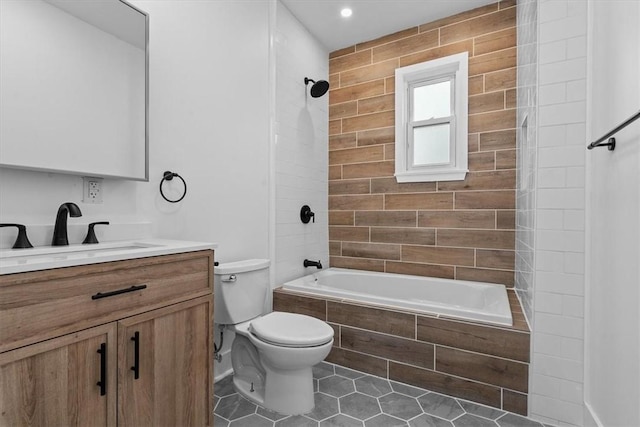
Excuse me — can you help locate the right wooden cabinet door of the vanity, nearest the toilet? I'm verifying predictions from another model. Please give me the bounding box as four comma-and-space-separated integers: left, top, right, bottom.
118, 296, 213, 427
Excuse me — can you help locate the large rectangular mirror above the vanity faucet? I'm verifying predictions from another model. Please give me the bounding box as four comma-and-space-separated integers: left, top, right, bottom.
0, 0, 149, 181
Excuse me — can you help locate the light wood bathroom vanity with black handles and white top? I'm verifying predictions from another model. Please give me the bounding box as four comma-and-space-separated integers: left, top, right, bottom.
0, 244, 214, 427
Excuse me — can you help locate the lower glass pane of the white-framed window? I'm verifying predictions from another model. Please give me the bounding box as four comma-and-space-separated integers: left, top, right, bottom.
413, 123, 451, 166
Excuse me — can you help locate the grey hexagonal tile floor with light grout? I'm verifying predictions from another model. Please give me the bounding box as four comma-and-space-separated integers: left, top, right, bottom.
214, 362, 543, 427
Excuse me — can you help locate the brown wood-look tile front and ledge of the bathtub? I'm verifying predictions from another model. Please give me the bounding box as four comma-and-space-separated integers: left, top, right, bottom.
273, 288, 530, 415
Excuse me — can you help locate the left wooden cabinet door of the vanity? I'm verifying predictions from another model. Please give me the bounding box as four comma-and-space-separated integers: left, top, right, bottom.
0, 323, 117, 426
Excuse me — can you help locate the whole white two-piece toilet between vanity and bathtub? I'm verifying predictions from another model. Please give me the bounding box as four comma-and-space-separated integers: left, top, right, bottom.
214, 259, 333, 415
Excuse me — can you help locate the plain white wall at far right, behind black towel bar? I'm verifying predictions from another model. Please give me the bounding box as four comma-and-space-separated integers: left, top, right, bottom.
585, 1, 640, 426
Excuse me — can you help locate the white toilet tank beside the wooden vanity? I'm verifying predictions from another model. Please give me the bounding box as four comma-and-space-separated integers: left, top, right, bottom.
213, 259, 270, 325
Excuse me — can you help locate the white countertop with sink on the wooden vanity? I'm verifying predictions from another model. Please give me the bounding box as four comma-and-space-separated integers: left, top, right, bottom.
0, 239, 217, 275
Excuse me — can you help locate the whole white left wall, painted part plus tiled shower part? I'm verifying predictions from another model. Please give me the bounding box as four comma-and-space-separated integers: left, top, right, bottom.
0, 0, 329, 384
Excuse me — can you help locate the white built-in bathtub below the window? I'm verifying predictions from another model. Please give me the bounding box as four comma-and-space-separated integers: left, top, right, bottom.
282, 268, 513, 326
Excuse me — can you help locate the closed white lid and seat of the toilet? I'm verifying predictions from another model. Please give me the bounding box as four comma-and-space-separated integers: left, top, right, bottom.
249, 312, 333, 347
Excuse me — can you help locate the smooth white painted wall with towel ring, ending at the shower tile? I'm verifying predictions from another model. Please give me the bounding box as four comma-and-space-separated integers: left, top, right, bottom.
0, 0, 269, 262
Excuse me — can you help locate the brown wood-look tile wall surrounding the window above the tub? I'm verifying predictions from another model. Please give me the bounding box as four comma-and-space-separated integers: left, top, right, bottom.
329, 1, 516, 287
